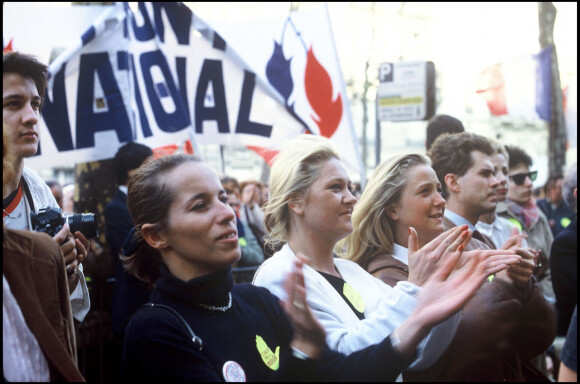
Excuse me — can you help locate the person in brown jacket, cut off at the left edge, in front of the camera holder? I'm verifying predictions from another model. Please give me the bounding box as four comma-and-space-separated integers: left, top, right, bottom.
2, 124, 84, 382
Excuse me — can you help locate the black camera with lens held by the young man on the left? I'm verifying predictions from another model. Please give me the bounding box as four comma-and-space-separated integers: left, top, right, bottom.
30, 208, 99, 239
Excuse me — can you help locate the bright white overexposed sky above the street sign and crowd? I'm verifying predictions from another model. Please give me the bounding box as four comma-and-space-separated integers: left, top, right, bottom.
186, 2, 578, 115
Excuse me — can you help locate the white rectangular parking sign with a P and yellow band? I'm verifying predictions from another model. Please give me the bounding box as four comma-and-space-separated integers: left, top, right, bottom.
377, 60, 435, 121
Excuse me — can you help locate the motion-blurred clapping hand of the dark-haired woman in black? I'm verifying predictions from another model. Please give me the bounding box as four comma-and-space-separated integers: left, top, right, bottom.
282, 252, 326, 359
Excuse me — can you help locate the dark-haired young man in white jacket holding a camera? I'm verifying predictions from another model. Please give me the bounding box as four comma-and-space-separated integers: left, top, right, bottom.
2, 52, 90, 321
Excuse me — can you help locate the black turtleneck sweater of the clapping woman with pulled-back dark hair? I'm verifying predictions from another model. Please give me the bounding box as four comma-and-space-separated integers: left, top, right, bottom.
123, 266, 410, 382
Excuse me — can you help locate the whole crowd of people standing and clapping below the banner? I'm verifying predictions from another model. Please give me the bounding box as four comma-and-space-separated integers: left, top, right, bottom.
3, 52, 577, 382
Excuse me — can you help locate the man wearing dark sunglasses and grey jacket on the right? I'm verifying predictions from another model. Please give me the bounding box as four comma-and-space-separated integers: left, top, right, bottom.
498, 145, 556, 303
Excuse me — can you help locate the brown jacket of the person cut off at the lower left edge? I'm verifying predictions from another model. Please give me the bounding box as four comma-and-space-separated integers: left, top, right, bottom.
2, 226, 85, 381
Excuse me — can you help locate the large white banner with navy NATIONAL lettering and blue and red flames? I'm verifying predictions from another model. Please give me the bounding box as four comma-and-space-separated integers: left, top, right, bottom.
6, 2, 362, 180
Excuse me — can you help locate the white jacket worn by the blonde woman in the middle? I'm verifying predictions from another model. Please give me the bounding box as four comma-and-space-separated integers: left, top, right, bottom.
253, 244, 460, 370
